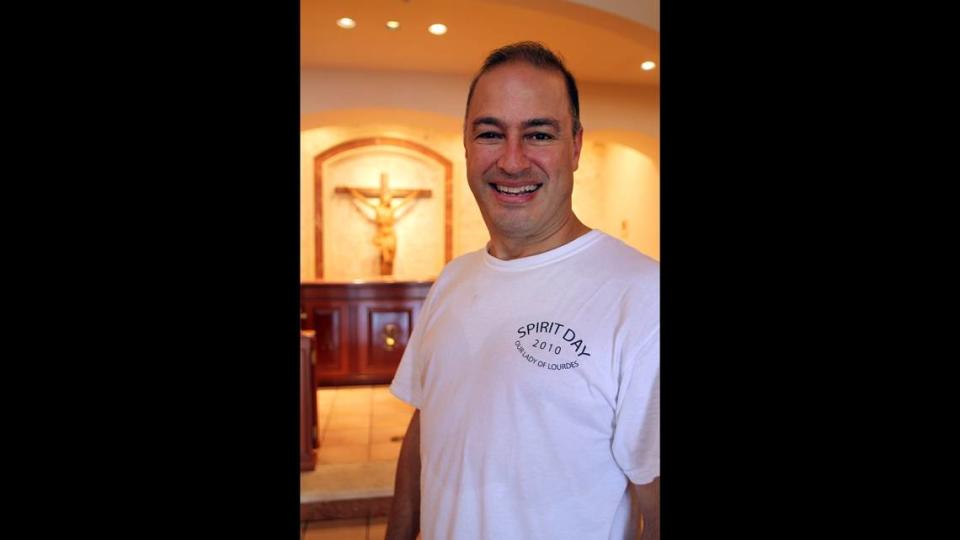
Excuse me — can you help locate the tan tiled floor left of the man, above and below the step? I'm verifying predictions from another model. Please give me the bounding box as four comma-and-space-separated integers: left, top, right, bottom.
300, 385, 414, 540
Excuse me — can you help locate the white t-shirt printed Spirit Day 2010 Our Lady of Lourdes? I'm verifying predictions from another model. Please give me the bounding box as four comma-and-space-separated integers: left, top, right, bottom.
390, 230, 660, 540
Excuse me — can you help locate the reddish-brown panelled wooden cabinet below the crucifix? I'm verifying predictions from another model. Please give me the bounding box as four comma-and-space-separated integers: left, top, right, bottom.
300, 281, 431, 386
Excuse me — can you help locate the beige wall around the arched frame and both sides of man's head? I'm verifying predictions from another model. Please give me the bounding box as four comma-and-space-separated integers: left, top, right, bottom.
300, 69, 660, 280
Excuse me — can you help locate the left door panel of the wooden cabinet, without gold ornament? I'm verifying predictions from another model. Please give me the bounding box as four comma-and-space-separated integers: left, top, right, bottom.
304, 300, 350, 386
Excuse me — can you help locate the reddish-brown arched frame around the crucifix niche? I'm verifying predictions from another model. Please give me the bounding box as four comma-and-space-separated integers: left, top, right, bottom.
313, 137, 453, 279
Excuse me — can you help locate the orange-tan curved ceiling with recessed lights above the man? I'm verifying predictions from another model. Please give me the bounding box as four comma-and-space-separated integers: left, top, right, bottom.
300, 0, 660, 86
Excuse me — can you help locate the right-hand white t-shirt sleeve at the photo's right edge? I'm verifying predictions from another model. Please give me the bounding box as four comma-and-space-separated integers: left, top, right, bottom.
612, 328, 660, 484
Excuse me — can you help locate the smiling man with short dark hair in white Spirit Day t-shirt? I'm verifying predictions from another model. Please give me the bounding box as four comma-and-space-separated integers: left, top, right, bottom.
387, 42, 660, 540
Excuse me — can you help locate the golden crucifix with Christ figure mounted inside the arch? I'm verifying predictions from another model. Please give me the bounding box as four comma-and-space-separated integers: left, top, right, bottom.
334, 173, 430, 276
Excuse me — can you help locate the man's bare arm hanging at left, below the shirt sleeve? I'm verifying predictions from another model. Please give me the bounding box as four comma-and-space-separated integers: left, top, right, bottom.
386, 410, 420, 540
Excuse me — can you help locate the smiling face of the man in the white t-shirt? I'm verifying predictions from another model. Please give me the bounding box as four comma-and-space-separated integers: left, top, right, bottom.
463, 62, 583, 241
